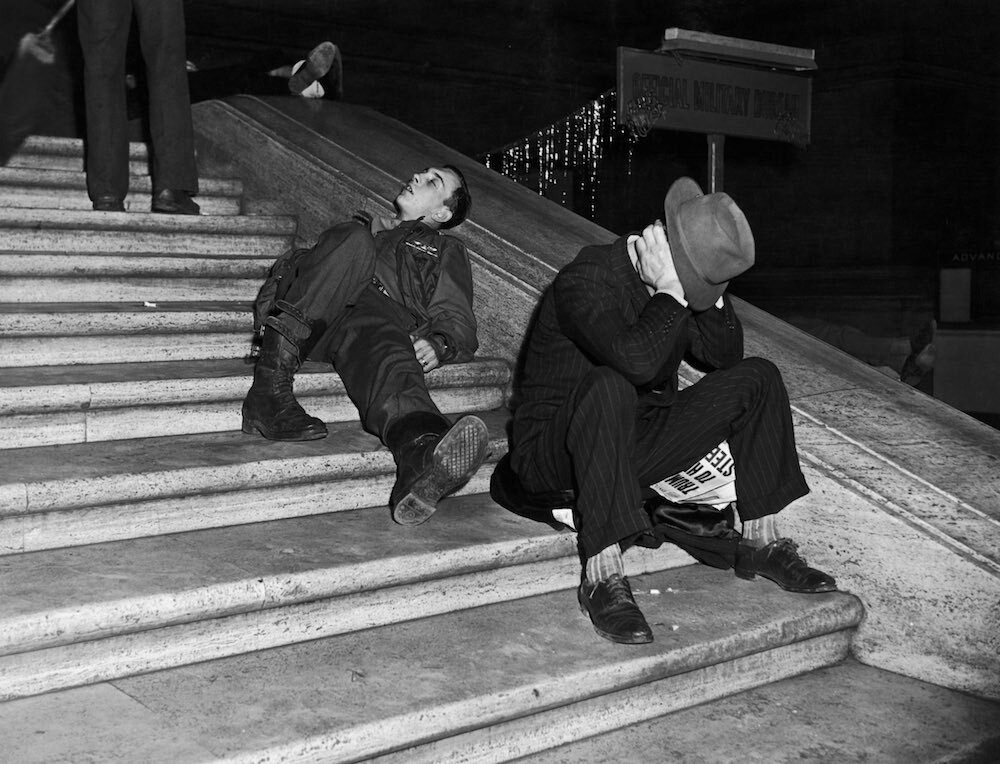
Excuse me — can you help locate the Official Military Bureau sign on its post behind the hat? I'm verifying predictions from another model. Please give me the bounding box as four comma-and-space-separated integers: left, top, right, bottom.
618, 28, 816, 193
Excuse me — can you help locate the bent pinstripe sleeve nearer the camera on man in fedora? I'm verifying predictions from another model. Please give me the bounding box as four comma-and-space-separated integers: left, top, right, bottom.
553, 261, 691, 387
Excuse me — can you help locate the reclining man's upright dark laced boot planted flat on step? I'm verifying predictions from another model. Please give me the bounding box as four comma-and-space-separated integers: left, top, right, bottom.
243, 302, 327, 440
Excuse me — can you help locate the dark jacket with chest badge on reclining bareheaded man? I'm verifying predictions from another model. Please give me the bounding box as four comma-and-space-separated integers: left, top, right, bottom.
375, 221, 479, 363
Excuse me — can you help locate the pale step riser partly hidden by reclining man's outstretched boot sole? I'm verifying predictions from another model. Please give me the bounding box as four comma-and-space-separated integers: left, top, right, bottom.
0, 463, 494, 555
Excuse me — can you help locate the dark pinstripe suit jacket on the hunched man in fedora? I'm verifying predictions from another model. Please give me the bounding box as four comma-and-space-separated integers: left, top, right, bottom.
513, 236, 743, 449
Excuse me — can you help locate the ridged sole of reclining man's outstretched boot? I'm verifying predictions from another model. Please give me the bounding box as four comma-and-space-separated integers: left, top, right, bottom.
392, 416, 489, 525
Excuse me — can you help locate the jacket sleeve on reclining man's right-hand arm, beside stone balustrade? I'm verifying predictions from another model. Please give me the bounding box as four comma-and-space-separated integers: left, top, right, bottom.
417, 236, 479, 363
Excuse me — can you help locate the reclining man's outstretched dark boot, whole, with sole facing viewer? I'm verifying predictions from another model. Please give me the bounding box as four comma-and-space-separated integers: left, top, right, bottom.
385, 411, 489, 525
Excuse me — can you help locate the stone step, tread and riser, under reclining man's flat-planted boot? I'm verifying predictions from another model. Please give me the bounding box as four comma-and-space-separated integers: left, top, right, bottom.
0, 410, 509, 554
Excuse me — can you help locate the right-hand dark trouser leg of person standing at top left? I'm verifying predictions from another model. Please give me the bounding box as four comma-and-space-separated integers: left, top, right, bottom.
133, 0, 198, 194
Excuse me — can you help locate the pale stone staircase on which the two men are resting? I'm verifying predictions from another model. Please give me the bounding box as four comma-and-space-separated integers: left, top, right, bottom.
0, 134, 862, 761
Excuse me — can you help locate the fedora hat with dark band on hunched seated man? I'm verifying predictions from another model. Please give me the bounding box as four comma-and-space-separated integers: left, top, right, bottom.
663, 178, 754, 311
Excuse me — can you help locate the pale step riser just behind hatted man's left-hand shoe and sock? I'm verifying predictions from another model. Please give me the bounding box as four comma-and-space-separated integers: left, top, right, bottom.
0, 550, 683, 700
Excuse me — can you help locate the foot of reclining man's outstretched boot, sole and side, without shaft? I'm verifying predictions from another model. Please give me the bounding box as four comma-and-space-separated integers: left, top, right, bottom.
389, 416, 489, 525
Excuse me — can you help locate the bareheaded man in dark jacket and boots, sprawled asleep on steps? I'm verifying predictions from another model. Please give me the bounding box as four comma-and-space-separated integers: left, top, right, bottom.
243, 165, 488, 525
